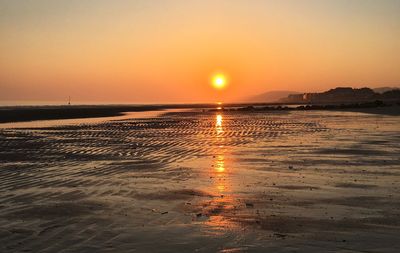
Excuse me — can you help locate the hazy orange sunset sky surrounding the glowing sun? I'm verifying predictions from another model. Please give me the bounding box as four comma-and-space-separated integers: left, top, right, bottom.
0, 0, 400, 104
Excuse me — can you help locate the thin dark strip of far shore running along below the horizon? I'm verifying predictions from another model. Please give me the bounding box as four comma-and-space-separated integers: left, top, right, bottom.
0, 101, 400, 123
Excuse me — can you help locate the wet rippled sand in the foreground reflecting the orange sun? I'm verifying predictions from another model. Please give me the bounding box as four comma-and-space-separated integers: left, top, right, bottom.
0, 111, 400, 252
